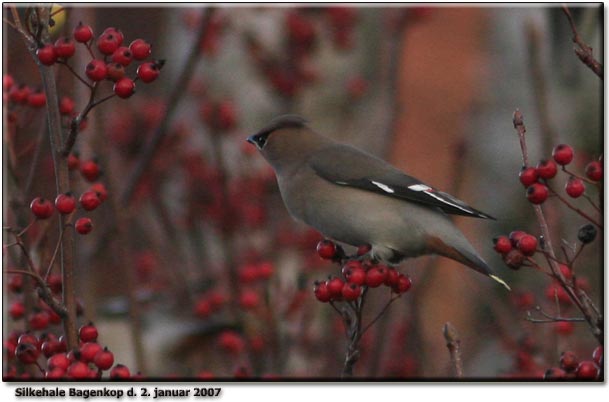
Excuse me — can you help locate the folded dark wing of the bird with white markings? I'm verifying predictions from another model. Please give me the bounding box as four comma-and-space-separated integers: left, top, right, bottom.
308, 144, 495, 219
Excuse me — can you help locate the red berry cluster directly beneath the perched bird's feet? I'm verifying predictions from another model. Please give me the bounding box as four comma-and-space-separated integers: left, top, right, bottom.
314, 240, 412, 303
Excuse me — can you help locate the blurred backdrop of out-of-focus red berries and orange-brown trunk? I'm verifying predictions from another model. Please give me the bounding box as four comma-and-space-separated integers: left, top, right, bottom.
3, 4, 604, 379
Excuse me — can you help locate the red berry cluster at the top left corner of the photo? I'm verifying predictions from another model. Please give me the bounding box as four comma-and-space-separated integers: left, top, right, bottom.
36, 22, 164, 98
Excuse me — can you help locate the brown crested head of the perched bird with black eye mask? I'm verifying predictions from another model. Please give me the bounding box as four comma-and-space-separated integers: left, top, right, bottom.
247, 115, 325, 171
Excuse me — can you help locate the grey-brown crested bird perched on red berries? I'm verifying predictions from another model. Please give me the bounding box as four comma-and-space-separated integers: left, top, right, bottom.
247, 115, 510, 289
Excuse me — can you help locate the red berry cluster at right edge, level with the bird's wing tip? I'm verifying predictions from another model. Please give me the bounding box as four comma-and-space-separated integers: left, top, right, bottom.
519, 144, 603, 204
